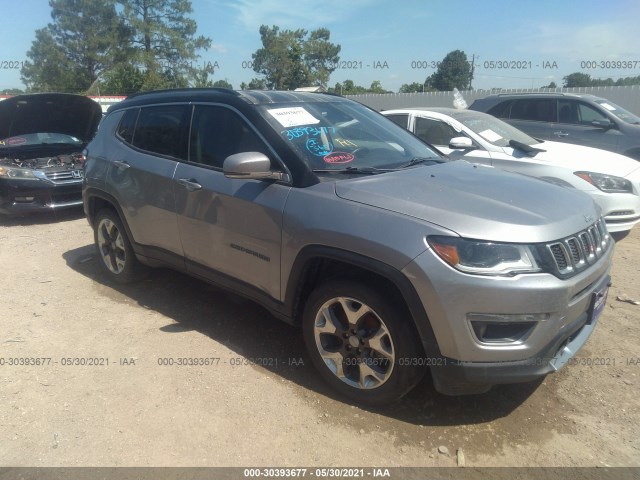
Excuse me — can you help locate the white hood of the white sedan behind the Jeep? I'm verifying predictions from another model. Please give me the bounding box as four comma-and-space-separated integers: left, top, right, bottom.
504, 141, 640, 177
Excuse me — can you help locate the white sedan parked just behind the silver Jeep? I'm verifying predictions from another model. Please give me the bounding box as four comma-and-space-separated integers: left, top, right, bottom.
382, 108, 640, 236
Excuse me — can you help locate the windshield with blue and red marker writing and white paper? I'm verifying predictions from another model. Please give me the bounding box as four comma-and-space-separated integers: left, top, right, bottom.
261, 101, 443, 170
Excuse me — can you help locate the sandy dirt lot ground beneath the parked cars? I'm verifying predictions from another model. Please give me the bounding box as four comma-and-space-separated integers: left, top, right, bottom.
0, 212, 640, 467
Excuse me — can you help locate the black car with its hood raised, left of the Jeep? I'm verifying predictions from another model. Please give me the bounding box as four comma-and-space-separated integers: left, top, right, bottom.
0, 93, 102, 215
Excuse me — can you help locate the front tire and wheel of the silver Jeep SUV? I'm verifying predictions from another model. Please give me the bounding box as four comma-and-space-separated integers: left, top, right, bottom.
302, 280, 426, 406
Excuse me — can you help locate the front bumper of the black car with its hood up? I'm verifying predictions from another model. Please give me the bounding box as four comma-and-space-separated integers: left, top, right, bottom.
0, 178, 82, 215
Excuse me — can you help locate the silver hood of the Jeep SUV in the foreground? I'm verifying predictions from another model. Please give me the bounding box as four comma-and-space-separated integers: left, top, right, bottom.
336, 161, 600, 243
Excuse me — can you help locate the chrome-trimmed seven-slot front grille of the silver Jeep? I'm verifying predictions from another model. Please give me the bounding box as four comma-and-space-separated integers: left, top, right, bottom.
546, 218, 612, 276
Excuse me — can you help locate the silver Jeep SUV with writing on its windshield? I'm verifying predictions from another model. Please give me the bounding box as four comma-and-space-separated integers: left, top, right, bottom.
83, 89, 614, 405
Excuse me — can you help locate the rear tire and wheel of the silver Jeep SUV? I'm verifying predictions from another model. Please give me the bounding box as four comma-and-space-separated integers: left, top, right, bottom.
93, 208, 143, 283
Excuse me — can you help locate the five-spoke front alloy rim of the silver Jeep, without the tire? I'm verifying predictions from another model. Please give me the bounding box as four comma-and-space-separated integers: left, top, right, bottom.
313, 297, 395, 390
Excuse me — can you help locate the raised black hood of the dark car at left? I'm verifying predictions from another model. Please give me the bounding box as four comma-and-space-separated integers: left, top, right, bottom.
0, 93, 102, 142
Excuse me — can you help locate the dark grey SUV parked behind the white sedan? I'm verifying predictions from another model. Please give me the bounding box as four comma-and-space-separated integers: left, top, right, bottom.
469, 93, 640, 160
